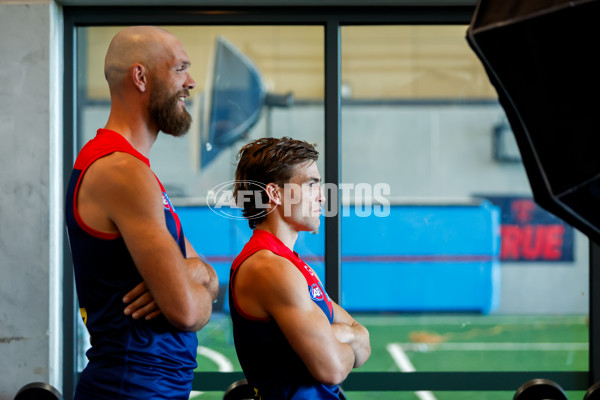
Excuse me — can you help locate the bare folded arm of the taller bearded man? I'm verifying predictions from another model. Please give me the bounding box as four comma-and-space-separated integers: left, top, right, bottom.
78, 153, 216, 331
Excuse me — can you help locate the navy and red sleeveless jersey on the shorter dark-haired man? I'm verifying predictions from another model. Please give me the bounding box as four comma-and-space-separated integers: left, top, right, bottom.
229, 229, 339, 400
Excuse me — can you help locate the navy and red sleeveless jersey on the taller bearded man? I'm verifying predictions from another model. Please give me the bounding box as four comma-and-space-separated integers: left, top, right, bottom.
66, 129, 198, 400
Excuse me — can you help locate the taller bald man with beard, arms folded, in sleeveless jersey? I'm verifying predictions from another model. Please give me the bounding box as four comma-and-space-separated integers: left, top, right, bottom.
66, 27, 218, 400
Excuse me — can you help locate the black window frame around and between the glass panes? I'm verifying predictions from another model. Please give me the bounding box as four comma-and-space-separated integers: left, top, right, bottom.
63, 4, 600, 398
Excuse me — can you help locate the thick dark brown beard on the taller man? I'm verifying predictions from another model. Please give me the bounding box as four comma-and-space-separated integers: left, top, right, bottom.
149, 83, 192, 137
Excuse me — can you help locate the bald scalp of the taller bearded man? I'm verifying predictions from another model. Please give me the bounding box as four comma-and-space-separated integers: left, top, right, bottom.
104, 26, 178, 91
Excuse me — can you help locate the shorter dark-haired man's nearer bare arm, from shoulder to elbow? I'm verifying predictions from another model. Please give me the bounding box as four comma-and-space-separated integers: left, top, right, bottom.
234, 250, 355, 384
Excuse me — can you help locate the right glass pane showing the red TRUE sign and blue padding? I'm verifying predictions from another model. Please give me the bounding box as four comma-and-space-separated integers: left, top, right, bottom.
341, 26, 588, 374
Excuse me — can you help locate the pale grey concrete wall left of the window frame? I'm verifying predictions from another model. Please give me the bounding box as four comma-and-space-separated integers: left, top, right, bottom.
0, 1, 62, 400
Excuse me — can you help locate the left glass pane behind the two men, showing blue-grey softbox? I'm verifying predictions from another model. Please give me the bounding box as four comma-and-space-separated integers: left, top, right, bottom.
77, 26, 325, 378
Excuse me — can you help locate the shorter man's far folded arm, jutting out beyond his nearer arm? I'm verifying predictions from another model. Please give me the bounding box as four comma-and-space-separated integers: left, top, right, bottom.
331, 302, 371, 368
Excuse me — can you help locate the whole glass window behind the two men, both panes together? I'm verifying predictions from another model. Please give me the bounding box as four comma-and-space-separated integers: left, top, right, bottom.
70, 16, 589, 400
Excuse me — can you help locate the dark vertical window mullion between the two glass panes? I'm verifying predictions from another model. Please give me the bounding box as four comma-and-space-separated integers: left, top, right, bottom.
325, 19, 341, 303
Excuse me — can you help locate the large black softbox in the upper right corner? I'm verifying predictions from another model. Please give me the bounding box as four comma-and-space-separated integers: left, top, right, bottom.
467, 0, 600, 243
